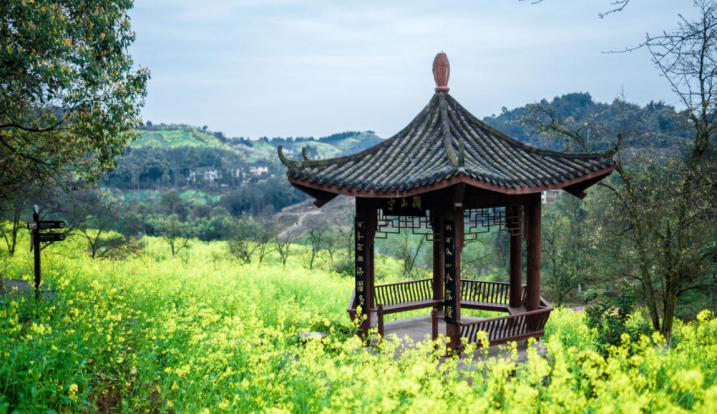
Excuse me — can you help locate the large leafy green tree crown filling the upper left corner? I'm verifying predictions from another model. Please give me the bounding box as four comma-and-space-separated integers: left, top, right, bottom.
0, 0, 149, 201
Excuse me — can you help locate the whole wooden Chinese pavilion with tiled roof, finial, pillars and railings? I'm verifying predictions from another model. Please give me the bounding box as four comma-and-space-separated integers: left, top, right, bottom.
278, 53, 614, 348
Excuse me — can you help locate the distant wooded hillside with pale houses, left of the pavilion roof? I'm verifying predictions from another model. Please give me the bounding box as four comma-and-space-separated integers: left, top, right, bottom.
102, 123, 382, 215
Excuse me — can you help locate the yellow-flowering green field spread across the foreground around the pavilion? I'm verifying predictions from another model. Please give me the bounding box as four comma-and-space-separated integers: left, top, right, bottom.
0, 239, 717, 413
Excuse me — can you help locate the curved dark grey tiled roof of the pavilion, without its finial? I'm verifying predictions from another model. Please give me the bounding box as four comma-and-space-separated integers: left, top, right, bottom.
279, 91, 613, 195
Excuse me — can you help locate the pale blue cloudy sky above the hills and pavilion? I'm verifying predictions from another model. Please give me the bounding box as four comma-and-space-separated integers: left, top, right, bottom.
130, 0, 694, 138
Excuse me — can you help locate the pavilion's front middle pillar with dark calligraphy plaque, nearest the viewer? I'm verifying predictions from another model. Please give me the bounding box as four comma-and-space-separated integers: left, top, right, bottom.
443, 184, 465, 349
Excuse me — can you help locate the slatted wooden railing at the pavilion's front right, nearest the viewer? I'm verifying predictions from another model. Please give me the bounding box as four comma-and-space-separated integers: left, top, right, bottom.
459, 298, 553, 346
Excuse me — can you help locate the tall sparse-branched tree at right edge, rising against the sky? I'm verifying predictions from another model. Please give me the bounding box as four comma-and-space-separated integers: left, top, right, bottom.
619, 0, 717, 338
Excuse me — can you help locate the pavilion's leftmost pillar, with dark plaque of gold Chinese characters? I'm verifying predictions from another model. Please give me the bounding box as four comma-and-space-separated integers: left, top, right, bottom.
354, 198, 377, 336
